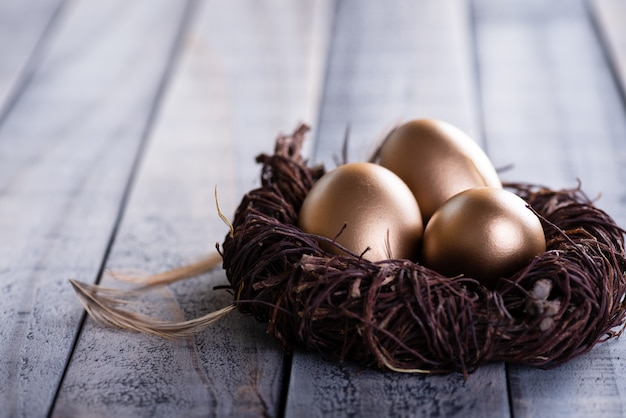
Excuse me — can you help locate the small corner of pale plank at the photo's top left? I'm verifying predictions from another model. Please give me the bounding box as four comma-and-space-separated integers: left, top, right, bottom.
0, 0, 63, 116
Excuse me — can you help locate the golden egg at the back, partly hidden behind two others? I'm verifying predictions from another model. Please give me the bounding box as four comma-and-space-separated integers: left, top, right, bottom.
379, 119, 502, 223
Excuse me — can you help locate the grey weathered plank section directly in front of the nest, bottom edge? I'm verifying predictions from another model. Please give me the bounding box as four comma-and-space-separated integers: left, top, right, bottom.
288, 352, 508, 417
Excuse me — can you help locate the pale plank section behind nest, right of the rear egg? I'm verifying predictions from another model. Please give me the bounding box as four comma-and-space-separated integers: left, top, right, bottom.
476, 0, 626, 217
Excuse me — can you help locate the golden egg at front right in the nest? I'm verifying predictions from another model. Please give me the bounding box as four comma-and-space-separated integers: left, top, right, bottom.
422, 187, 546, 288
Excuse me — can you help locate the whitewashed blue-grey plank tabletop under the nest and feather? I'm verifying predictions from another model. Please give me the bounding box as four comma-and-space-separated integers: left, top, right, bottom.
0, 0, 626, 417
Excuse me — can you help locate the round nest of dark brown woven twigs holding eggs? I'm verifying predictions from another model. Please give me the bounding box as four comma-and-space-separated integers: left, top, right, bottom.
223, 126, 626, 374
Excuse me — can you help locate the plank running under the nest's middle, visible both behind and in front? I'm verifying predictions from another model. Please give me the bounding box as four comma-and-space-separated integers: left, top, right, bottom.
286, 1, 509, 417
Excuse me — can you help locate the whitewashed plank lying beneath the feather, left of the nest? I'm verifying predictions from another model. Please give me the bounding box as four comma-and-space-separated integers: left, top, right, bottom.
53, 0, 332, 417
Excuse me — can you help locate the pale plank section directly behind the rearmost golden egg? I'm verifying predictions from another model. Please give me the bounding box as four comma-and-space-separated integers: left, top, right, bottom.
315, 1, 481, 165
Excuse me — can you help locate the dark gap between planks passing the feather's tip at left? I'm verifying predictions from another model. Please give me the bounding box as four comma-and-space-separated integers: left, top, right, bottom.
45, 0, 198, 418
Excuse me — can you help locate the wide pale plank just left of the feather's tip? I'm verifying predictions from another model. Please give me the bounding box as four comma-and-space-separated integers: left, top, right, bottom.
0, 0, 191, 417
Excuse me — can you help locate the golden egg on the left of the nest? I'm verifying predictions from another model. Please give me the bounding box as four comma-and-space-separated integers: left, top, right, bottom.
299, 162, 423, 261
